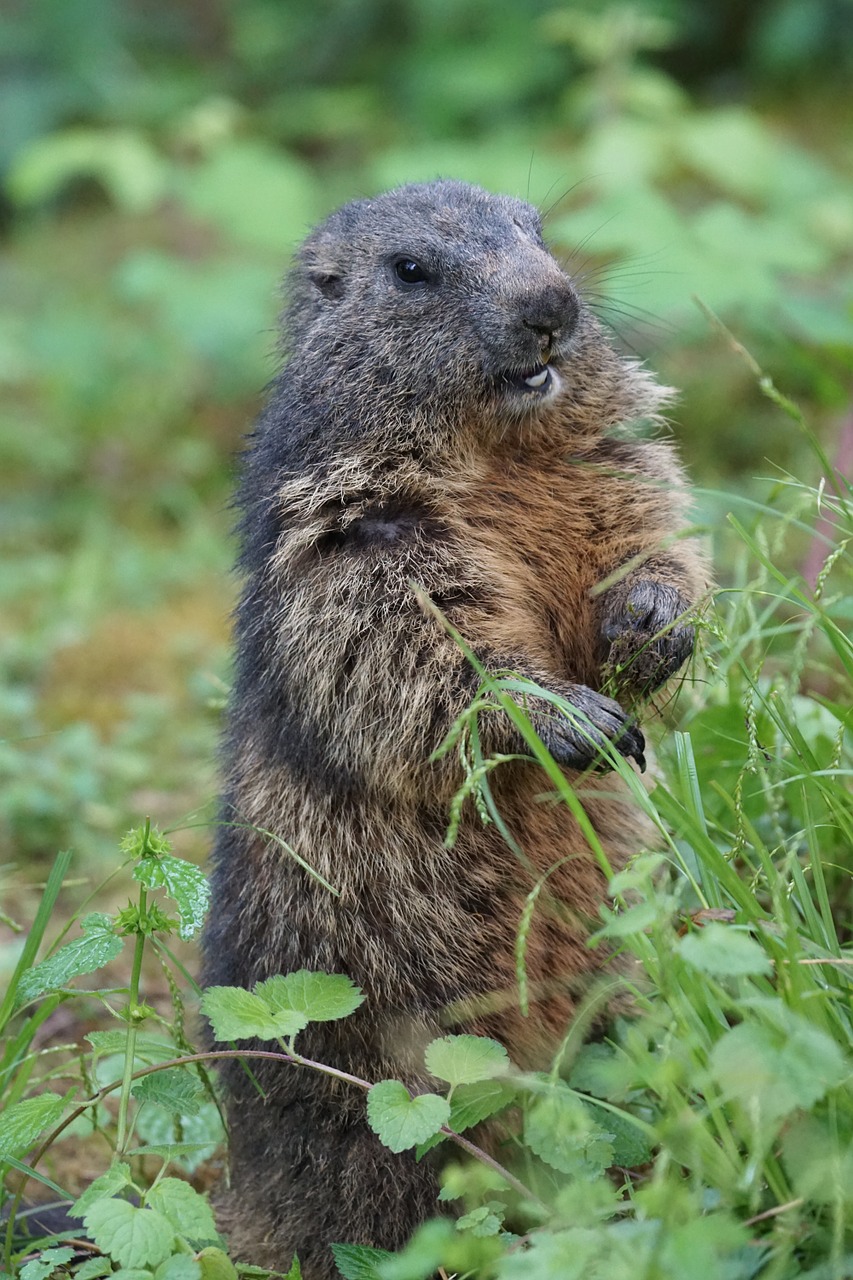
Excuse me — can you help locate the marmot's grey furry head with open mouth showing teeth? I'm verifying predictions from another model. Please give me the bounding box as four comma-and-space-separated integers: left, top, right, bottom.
284, 180, 666, 450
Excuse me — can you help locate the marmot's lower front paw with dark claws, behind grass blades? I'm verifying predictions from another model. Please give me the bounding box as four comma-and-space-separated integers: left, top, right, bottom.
532, 685, 646, 772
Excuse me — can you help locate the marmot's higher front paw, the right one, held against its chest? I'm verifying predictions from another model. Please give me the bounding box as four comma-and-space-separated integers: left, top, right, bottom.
602, 579, 694, 692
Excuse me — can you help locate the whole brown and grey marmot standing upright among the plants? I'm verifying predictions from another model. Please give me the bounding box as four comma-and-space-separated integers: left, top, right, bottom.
204, 180, 706, 1280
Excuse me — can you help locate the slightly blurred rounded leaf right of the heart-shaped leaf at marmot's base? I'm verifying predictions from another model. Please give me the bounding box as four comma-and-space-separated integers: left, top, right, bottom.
524, 1082, 613, 1179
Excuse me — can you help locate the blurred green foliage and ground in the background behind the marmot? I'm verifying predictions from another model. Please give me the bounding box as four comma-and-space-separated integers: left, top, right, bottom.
0, 0, 853, 880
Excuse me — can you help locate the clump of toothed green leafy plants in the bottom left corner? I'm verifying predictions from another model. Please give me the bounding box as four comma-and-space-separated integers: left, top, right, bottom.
0, 822, 236, 1280
